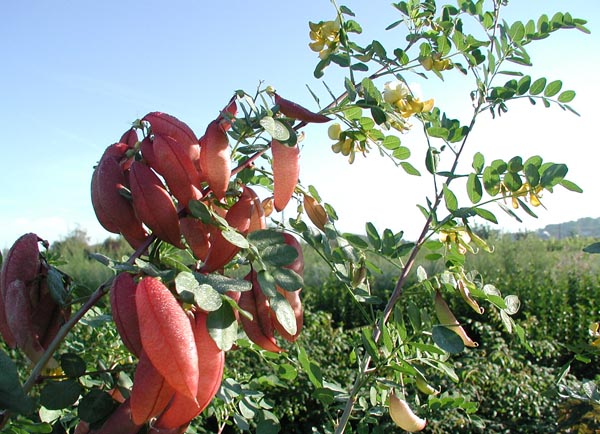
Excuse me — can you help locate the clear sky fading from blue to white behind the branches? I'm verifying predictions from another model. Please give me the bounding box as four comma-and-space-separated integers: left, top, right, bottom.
0, 0, 600, 248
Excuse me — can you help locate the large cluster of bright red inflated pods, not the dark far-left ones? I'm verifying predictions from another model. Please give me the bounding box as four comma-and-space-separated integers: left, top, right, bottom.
80, 94, 329, 433
